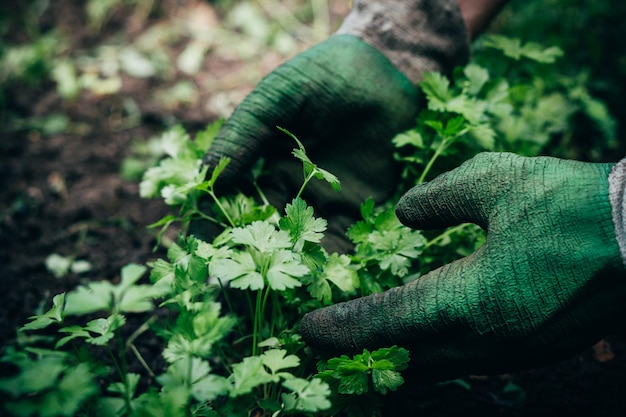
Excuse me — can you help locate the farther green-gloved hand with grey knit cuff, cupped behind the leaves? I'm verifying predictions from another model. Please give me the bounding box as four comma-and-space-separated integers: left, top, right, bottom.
204, 0, 469, 252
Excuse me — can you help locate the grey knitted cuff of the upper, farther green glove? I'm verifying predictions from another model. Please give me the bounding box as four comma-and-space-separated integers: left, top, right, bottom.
336, 0, 470, 84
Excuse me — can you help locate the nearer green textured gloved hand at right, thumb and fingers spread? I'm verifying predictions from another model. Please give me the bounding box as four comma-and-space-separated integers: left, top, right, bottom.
301, 153, 626, 379
